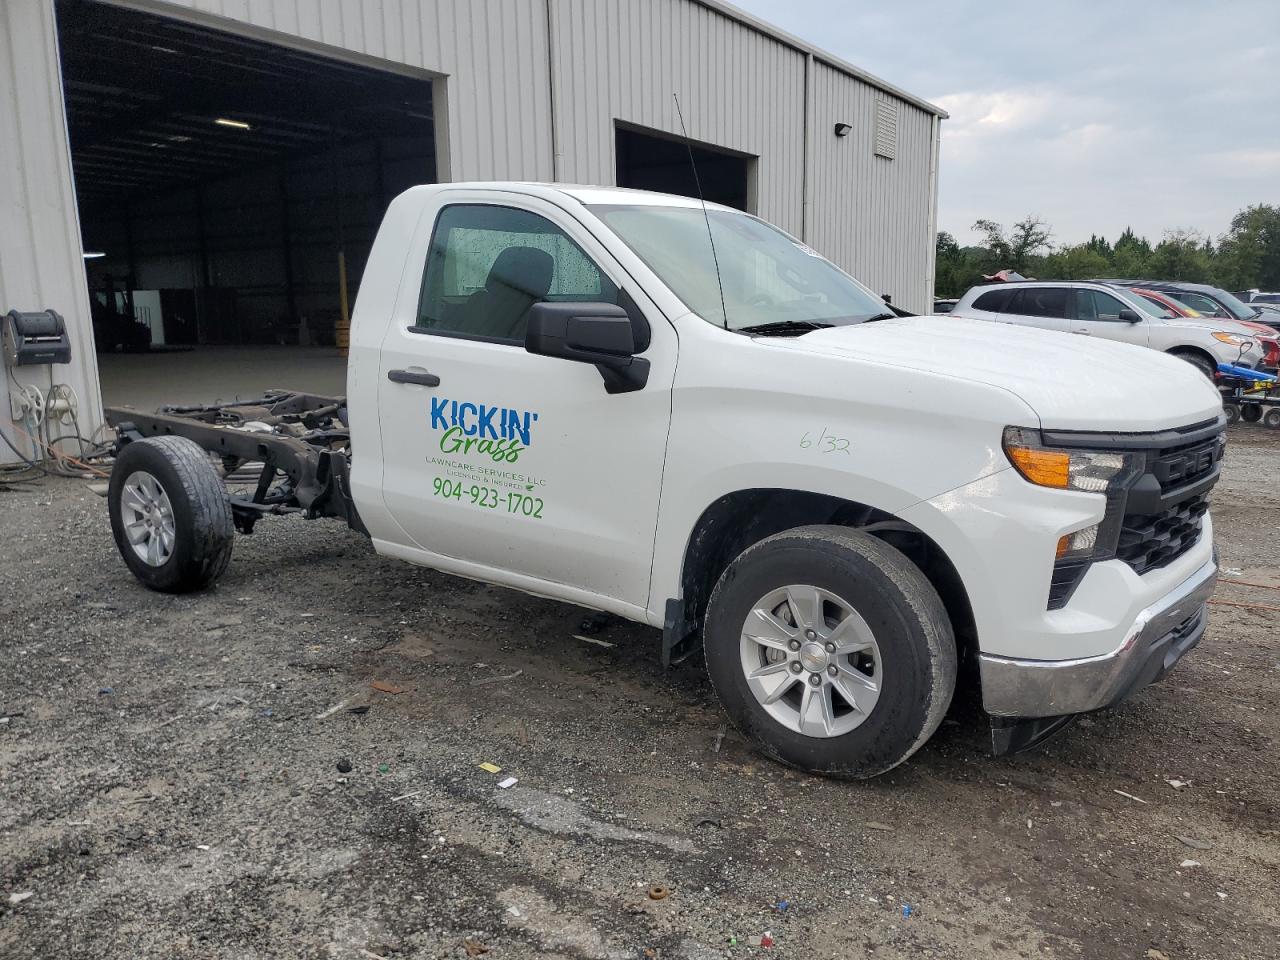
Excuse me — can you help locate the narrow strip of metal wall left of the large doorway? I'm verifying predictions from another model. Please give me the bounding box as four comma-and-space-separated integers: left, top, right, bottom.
0, 0, 102, 463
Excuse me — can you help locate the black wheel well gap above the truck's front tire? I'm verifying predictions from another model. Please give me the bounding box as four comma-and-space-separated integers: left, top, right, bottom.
663, 488, 978, 663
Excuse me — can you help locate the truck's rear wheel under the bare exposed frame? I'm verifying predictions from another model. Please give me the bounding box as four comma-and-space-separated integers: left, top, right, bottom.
108, 436, 236, 593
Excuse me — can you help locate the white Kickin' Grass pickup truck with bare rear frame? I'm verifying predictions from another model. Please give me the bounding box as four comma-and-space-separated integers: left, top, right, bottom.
109, 183, 1224, 777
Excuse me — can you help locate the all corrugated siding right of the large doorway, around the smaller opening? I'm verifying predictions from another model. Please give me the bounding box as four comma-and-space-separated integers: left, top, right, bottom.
133, 0, 933, 296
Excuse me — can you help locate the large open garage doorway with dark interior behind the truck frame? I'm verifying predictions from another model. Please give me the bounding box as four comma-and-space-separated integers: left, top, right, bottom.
56, 0, 436, 406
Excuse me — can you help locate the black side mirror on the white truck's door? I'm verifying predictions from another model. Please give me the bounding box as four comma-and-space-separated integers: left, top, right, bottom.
525, 302, 649, 393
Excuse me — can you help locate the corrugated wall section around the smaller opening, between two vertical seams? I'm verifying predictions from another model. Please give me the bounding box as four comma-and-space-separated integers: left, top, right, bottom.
552, 0, 805, 234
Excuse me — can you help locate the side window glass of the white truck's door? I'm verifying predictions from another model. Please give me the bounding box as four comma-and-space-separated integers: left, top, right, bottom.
413, 204, 618, 344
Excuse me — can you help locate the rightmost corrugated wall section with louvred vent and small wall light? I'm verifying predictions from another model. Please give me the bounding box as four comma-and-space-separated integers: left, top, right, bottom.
809, 63, 934, 311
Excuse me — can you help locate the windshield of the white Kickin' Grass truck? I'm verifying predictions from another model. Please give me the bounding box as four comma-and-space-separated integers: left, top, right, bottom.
590, 205, 892, 330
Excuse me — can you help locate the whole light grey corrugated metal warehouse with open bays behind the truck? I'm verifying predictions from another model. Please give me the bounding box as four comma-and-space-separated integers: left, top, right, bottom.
0, 0, 945, 462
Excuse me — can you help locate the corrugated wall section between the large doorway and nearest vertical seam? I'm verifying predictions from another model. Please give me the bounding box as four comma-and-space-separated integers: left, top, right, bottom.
140, 0, 552, 180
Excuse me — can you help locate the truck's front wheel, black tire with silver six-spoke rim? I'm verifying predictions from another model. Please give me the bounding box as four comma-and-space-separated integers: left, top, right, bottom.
704, 526, 956, 778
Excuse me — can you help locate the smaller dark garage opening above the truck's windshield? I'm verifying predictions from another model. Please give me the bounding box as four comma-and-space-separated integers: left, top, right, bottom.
616, 124, 755, 212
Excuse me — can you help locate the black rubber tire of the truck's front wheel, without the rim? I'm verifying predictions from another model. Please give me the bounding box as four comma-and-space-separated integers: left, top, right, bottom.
703, 526, 957, 778
